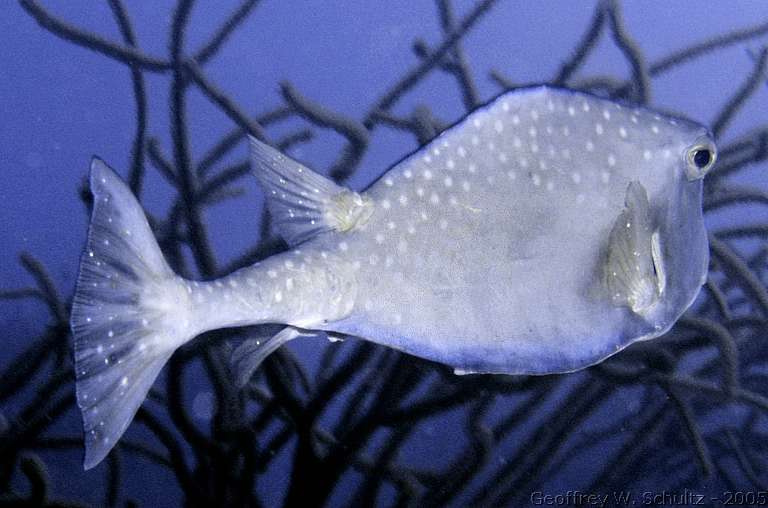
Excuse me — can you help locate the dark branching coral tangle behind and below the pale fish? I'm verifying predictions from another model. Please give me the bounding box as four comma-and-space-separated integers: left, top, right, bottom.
0, 0, 768, 506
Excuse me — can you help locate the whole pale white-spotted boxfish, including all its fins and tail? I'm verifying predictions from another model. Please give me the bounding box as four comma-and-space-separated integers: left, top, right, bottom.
71, 86, 716, 468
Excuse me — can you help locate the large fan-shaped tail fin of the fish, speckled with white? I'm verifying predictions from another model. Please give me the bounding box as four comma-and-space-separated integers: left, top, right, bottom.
71, 159, 195, 469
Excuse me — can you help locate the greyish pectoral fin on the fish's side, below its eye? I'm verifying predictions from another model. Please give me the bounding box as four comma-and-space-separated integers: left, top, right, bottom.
603, 181, 666, 315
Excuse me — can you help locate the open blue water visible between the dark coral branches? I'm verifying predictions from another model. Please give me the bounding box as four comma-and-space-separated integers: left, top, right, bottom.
0, 0, 768, 505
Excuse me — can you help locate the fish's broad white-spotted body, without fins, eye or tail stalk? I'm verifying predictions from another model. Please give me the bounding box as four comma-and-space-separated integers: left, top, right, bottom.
324, 88, 711, 374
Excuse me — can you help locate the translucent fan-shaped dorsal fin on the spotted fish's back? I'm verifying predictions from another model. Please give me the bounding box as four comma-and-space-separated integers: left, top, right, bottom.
250, 137, 373, 246
